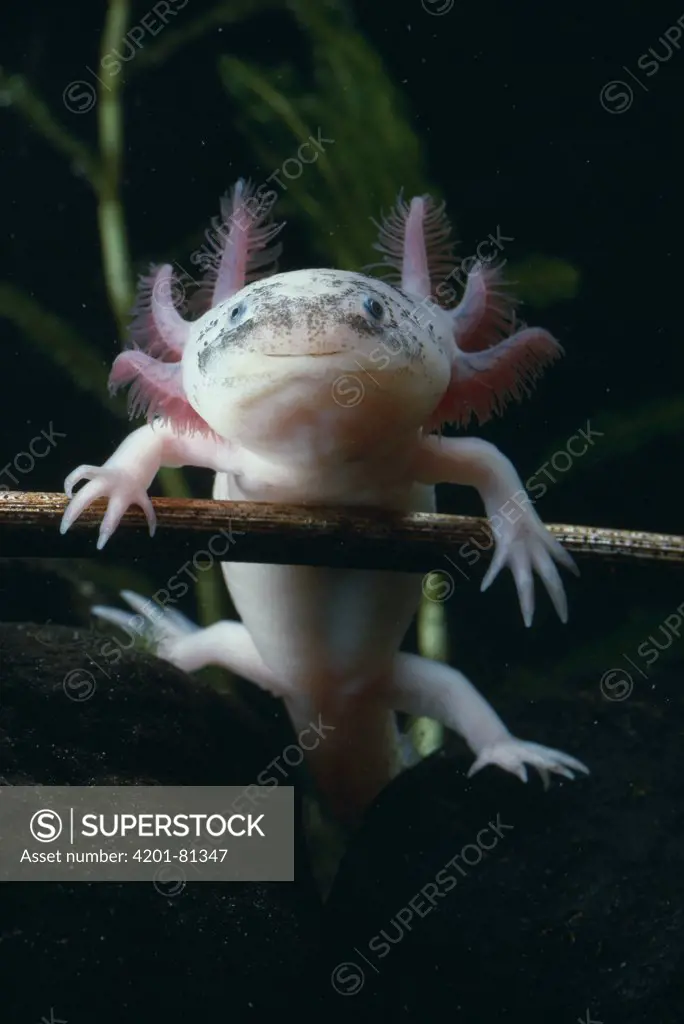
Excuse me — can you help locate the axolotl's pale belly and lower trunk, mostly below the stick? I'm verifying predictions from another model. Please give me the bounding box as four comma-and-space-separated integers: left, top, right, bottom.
213, 444, 435, 818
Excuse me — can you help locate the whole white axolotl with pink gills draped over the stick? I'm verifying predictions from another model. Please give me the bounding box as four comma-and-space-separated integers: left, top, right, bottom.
61, 180, 588, 822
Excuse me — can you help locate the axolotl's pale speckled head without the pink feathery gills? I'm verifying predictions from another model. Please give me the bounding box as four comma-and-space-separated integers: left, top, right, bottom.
182, 269, 451, 446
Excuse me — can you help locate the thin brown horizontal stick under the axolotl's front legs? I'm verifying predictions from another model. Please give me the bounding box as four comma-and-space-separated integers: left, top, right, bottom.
0, 492, 684, 577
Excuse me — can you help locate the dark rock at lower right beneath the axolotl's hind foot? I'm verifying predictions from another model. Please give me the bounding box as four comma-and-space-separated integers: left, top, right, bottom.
322, 668, 684, 1024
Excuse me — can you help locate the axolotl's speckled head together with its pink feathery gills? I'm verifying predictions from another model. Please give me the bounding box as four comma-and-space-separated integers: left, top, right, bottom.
110, 180, 562, 454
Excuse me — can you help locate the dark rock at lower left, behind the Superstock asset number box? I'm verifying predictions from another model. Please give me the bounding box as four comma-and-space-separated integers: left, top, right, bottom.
0, 625, 319, 1024
